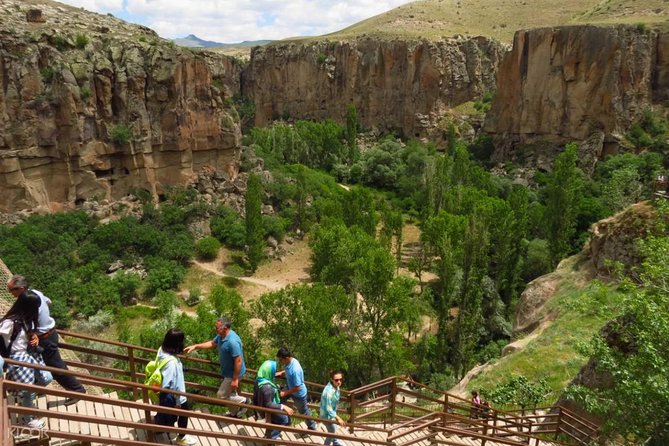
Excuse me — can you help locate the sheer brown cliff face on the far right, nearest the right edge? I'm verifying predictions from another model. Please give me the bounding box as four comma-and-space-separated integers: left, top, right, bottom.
484, 26, 669, 160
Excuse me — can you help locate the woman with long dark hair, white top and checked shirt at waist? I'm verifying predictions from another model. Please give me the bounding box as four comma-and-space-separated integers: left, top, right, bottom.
0, 291, 53, 429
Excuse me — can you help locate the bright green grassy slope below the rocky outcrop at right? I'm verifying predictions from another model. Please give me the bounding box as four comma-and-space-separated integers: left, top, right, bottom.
468, 258, 622, 404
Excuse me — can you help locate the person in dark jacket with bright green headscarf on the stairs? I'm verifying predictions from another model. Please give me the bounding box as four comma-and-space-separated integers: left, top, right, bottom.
253, 360, 293, 439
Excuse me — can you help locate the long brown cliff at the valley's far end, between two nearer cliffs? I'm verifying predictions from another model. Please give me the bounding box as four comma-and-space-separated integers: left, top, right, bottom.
242, 37, 507, 137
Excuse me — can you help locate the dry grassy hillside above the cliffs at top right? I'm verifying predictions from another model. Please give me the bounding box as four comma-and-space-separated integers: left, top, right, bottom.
280, 0, 669, 42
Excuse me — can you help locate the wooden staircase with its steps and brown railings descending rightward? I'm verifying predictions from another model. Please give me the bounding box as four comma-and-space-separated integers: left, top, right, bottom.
0, 332, 596, 446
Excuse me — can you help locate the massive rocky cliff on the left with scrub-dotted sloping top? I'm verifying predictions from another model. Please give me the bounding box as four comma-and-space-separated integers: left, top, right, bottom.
0, 0, 241, 212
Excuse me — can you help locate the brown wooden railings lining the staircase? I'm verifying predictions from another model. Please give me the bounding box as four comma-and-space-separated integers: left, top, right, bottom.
0, 331, 596, 446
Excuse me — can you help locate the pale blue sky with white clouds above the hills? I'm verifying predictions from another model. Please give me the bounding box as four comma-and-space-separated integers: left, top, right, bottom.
59, 0, 410, 43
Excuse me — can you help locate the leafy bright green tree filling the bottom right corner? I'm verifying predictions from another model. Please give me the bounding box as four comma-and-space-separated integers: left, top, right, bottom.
570, 203, 669, 446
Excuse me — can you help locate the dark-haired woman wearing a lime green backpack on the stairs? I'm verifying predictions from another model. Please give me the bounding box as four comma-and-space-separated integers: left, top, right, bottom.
149, 328, 197, 446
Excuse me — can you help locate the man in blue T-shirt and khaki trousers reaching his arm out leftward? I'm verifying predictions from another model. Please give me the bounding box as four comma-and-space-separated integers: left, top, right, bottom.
184, 317, 251, 418
